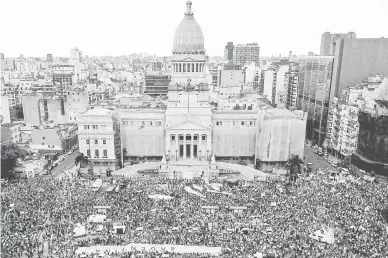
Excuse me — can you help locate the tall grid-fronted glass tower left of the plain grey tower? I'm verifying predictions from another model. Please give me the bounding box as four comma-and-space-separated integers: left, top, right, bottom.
296, 56, 334, 145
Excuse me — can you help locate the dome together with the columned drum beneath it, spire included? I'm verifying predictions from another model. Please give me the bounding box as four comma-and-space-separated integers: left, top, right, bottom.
170, 1, 207, 88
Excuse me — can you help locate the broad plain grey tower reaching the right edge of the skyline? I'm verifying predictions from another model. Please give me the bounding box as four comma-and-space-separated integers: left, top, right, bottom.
331, 38, 388, 98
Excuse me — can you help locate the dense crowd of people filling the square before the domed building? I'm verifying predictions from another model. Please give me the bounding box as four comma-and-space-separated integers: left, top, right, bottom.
1, 167, 388, 258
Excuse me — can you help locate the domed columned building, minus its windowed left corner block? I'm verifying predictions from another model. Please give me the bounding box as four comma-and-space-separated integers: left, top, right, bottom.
113, 1, 306, 177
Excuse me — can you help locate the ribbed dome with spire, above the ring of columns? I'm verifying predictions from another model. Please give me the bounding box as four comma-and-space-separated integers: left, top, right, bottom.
172, 1, 205, 54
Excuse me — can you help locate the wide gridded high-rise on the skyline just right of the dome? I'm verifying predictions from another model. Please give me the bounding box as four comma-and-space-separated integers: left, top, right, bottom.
233, 43, 260, 67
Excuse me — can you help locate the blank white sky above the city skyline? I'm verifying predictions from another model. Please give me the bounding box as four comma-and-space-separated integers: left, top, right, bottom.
0, 0, 388, 58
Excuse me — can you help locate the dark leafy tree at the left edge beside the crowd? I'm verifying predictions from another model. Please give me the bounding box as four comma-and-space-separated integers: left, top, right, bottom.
1, 142, 27, 178
